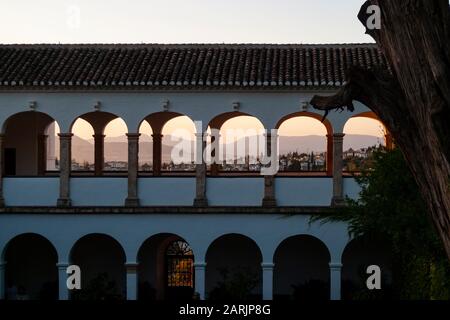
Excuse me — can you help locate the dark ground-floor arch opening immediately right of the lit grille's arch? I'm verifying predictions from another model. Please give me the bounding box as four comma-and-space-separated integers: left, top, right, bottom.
205, 233, 262, 300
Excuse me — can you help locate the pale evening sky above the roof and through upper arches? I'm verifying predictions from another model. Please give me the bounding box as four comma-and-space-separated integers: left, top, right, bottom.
0, 0, 380, 139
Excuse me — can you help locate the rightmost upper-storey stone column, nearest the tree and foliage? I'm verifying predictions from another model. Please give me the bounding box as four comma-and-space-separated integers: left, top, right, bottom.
331, 133, 345, 206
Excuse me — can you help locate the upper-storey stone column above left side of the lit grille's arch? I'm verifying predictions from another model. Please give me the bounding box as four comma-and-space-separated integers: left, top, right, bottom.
125, 133, 140, 207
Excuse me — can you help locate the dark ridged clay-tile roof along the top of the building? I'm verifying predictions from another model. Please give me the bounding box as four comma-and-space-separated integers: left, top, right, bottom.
0, 44, 386, 90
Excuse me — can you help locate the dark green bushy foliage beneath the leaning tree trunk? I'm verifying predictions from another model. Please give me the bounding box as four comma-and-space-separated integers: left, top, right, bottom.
312, 149, 450, 300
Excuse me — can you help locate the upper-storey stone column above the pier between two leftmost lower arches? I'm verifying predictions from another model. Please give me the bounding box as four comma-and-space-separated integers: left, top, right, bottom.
57, 133, 73, 207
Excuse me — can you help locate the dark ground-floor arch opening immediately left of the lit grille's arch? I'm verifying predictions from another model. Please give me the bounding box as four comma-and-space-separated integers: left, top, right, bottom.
70, 233, 126, 300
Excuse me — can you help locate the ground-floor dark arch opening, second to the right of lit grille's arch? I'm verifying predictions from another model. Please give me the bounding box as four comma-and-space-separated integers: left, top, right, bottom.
273, 234, 331, 300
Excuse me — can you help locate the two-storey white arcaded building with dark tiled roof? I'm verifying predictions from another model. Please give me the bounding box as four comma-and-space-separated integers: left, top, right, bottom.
0, 44, 389, 300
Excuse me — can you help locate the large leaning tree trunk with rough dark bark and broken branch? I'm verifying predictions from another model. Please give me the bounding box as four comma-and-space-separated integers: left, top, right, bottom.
311, 0, 450, 259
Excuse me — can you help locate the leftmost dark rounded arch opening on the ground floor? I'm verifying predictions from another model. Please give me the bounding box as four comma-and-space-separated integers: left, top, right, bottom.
2, 233, 58, 300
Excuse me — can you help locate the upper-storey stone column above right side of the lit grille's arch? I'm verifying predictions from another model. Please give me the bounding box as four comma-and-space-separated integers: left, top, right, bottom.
194, 133, 208, 207
